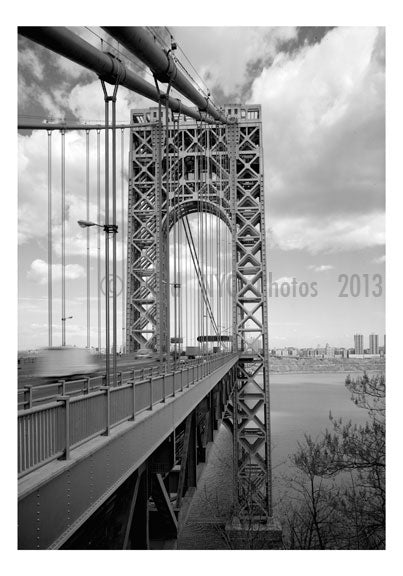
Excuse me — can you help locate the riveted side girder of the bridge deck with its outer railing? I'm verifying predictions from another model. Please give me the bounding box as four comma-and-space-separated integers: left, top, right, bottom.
18, 354, 238, 549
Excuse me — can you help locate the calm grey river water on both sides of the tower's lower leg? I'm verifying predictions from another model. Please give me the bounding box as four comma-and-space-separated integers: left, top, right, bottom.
178, 372, 374, 550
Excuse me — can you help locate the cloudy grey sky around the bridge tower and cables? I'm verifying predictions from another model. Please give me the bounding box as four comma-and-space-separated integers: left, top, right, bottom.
18, 26, 385, 349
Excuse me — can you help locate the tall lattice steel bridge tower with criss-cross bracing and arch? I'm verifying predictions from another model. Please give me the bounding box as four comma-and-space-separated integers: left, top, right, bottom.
127, 105, 272, 518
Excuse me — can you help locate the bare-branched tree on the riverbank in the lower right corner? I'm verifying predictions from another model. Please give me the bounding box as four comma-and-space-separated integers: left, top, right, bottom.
284, 374, 385, 549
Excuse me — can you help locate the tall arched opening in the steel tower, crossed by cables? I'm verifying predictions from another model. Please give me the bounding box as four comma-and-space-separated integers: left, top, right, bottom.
165, 204, 233, 360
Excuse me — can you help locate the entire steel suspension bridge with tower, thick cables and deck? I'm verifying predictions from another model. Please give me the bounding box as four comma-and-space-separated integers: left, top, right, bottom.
18, 27, 281, 549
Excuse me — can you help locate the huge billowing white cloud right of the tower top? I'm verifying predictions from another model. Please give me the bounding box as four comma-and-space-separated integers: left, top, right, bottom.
251, 28, 385, 252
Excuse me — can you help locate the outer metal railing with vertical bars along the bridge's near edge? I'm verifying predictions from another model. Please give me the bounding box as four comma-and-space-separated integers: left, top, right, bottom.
18, 354, 236, 478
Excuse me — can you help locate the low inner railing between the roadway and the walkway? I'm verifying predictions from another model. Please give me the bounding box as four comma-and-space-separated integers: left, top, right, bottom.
18, 354, 217, 410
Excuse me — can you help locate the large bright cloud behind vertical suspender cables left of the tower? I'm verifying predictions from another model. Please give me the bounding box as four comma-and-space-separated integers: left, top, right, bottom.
18, 131, 128, 245
